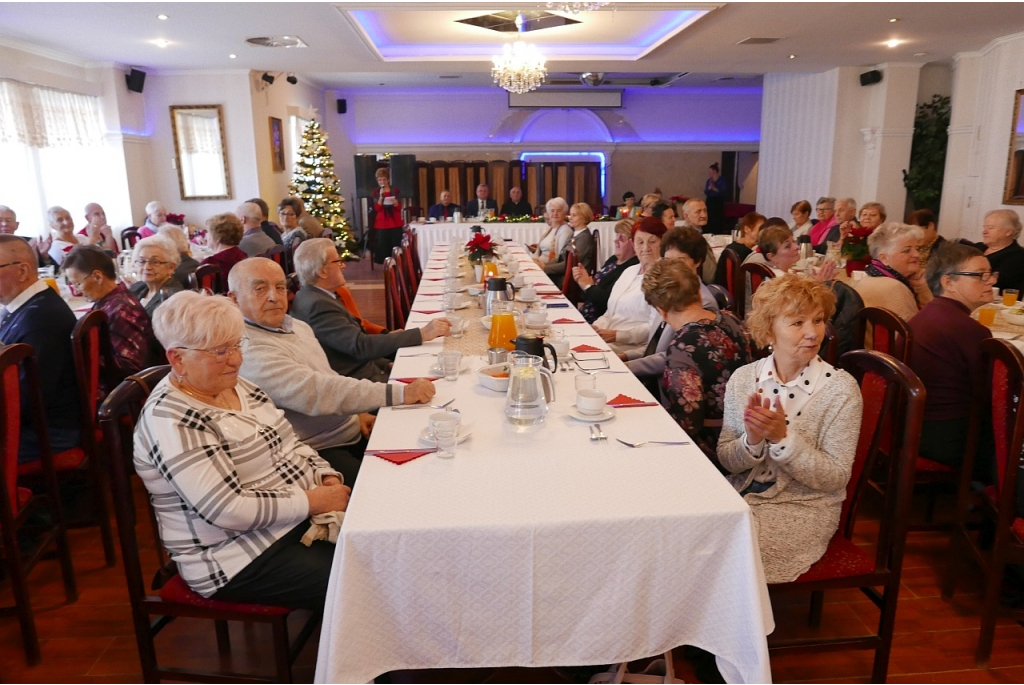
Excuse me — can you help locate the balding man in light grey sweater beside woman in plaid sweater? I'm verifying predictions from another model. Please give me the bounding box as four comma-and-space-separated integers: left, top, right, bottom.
227, 257, 434, 482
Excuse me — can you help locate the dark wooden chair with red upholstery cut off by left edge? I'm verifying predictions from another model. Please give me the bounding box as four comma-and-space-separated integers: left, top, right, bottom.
0, 344, 78, 666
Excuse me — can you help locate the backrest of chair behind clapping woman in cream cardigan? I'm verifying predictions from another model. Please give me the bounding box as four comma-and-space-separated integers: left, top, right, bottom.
840, 350, 926, 569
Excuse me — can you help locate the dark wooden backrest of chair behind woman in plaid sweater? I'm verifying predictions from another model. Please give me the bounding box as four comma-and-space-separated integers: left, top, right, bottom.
98, 366, 171, 618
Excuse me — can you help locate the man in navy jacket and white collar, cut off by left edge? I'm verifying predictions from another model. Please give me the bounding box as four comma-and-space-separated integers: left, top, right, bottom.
0, 236, 79, 462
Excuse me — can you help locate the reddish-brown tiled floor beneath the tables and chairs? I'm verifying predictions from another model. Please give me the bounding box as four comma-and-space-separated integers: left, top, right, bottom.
0, 254, 1024, 683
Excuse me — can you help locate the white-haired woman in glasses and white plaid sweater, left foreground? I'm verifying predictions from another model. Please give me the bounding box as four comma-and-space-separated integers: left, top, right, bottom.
134, 292, 350, 610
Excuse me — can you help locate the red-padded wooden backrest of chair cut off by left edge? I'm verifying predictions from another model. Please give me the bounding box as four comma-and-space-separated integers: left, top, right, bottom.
0, 343, 59, 518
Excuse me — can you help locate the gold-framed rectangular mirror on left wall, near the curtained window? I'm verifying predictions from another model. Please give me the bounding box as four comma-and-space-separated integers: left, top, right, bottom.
171, 104, 231, 200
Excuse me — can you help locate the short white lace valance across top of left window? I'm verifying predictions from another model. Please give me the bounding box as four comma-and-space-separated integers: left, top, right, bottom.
0, 79, 103, 147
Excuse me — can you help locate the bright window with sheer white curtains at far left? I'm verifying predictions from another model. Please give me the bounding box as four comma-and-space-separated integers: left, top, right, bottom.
0, 79, 125, 236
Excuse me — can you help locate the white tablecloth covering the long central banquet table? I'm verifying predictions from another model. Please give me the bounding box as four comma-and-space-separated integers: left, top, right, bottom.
316, 240, 774, 683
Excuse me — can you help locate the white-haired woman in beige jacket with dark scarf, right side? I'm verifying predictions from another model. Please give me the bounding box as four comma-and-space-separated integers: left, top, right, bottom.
854, 222, 933, 322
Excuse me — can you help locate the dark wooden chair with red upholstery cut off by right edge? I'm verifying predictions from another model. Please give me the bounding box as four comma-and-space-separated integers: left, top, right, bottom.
942, 339, 1024, 669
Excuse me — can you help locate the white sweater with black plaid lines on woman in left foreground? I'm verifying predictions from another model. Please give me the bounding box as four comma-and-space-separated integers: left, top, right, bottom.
135, 377, 337, 597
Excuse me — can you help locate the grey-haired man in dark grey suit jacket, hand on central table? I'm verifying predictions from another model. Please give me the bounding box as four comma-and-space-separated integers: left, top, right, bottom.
291, 239, 451, 383
